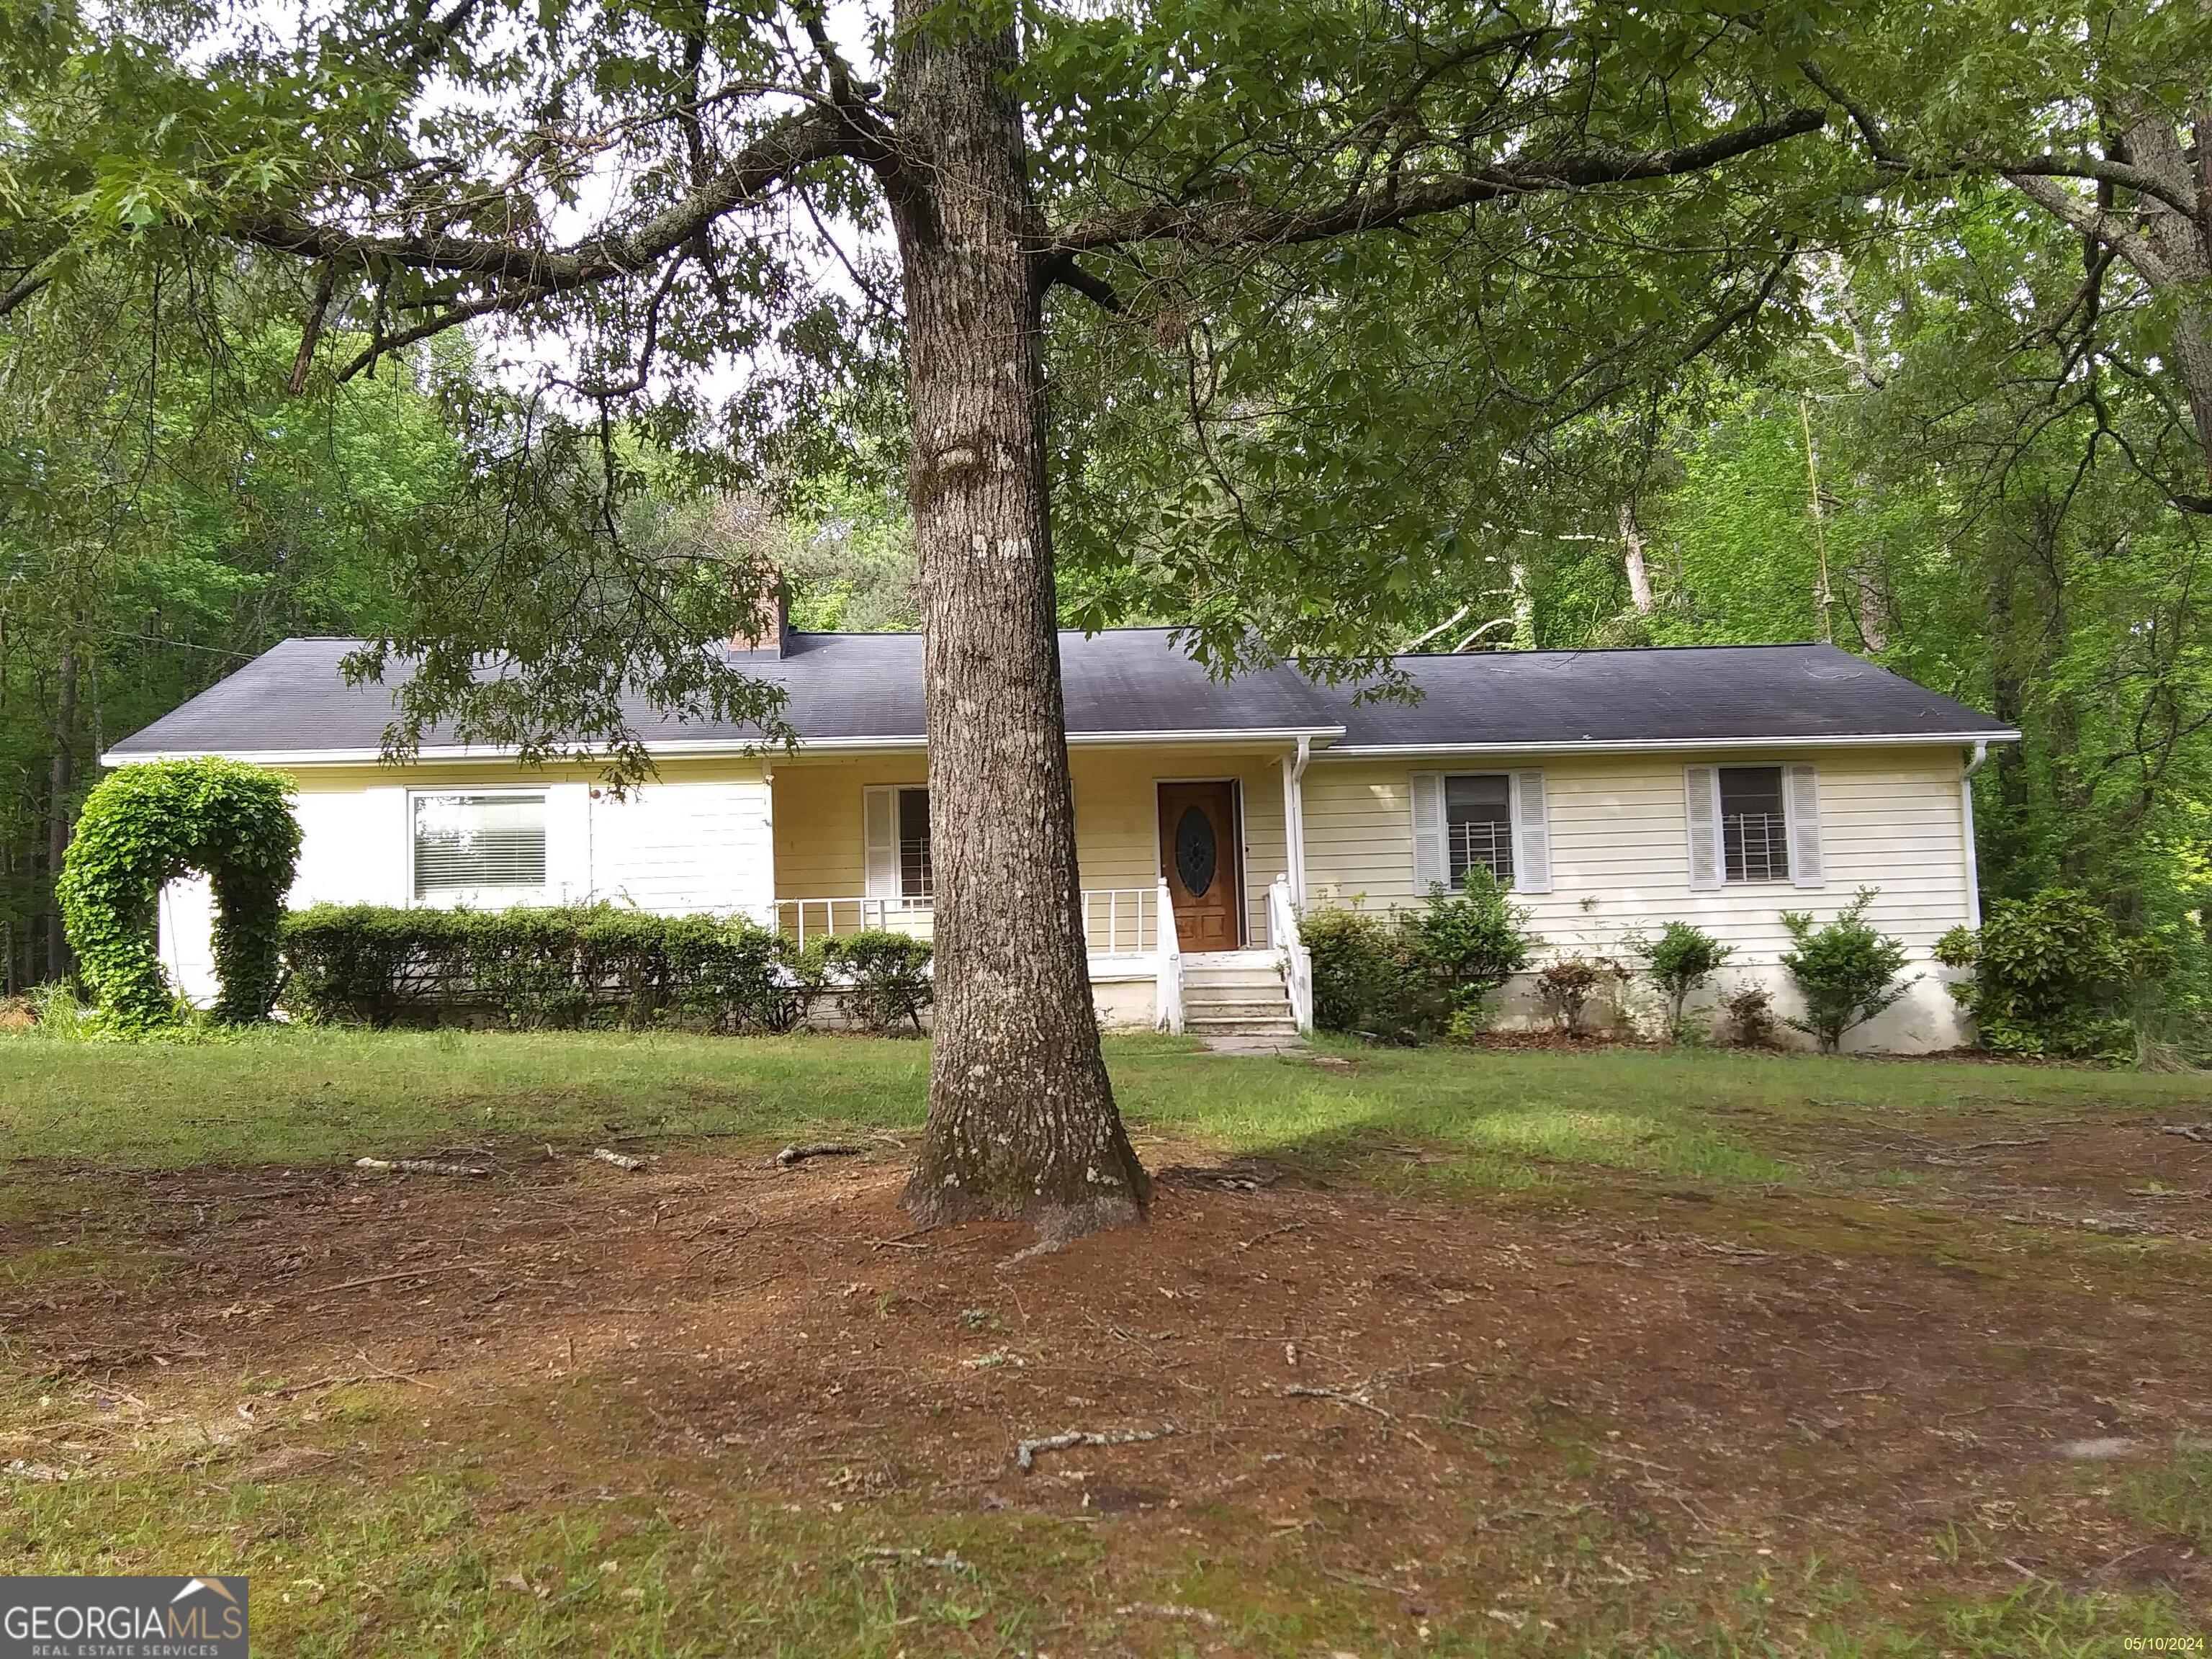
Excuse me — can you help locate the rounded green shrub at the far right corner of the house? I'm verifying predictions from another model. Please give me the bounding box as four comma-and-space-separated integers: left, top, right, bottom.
1936, 887, 2170, 1059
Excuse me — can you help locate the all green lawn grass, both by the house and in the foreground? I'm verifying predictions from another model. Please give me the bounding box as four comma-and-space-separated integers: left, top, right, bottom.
0, 1031, 2212, 1659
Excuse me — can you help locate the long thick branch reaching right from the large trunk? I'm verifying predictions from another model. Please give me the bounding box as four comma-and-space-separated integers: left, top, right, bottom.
1042, 109, 1827, 258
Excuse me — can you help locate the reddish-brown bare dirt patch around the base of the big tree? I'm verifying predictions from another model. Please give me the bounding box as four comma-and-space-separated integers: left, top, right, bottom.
0, 1119, 2212, 1650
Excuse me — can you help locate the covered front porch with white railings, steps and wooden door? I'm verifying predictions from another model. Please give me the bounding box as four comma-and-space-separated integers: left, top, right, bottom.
768, 743, 1312, 1031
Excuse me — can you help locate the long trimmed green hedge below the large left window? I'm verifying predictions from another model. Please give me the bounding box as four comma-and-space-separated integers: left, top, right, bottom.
283, 904, 931, 1033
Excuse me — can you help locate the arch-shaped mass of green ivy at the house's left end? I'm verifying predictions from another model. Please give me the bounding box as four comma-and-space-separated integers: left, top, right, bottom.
58, 761, 299, 1033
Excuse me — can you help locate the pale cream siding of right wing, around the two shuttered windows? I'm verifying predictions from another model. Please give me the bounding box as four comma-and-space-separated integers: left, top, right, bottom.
1305, 745, 1966, 964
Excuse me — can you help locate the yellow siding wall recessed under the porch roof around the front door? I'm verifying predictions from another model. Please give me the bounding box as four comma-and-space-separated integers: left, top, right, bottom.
774, 745, 1285, 940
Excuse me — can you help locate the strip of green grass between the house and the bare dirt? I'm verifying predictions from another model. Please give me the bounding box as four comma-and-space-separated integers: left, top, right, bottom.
0, 1031, 2212, 1188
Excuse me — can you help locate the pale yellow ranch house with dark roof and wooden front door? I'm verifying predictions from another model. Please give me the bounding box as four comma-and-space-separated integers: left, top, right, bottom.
104, 628, 2018, 1053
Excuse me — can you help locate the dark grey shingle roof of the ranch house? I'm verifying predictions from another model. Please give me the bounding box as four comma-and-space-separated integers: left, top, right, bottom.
109, 628, 2006, 761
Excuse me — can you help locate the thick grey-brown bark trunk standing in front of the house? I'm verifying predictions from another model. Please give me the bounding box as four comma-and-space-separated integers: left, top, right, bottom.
891, 0, 1148, 1241
